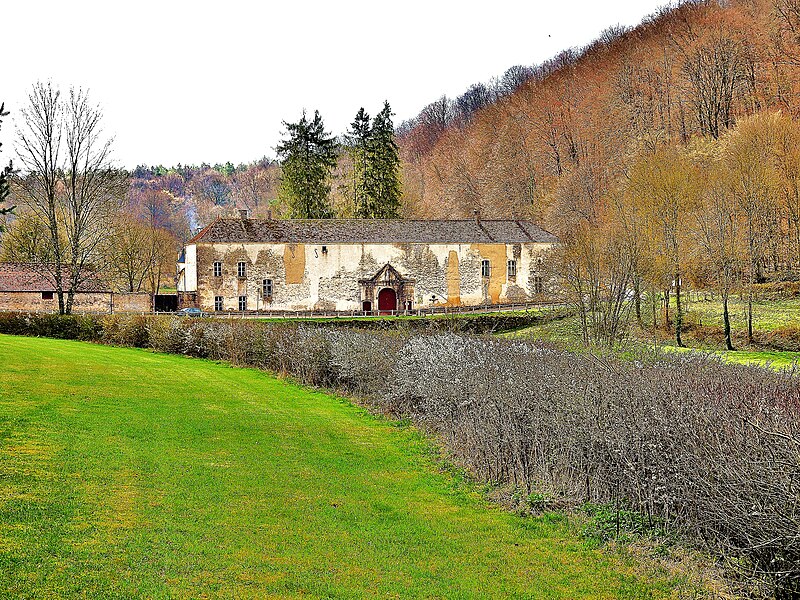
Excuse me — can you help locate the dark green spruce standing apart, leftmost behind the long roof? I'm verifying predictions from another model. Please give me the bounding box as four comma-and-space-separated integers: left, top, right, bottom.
277, 111, 337, 219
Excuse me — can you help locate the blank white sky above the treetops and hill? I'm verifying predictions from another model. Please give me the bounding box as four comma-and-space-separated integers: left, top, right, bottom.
0, 0, 666, 167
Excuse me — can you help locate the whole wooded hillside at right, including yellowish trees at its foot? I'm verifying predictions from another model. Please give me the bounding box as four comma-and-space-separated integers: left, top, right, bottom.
400, 0, 800, 348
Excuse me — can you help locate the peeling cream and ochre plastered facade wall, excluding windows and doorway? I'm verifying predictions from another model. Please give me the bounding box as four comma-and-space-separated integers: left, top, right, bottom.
186, 242, 551, 311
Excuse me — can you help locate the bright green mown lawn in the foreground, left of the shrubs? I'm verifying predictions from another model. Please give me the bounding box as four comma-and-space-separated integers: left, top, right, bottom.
0, 336, 681, 598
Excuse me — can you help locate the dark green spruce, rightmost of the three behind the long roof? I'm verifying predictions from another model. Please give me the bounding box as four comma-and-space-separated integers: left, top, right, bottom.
366, 102, 400, 219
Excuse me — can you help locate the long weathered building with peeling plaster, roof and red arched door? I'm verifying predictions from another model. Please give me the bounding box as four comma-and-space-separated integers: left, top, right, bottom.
178, 215, 558, 312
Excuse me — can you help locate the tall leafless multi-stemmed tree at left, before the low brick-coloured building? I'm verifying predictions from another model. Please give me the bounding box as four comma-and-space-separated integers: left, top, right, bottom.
17, 82, 127, 314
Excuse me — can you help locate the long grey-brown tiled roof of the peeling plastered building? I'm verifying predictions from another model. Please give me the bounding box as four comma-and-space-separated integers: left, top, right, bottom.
189, 219, 558, 244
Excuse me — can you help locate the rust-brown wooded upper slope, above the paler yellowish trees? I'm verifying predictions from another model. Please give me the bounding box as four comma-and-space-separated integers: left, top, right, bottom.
400, 0, 800, 224
